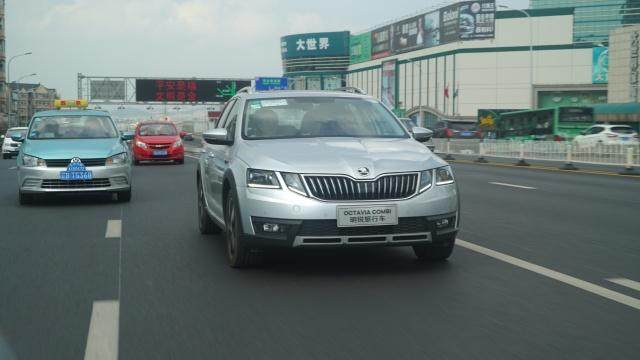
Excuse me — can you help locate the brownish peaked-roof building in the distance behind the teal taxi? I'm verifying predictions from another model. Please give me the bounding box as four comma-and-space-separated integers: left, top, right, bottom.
10, 83, 58, 126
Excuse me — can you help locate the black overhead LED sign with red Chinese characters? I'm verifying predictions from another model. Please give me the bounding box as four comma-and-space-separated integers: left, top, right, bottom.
136, 79, 251, 102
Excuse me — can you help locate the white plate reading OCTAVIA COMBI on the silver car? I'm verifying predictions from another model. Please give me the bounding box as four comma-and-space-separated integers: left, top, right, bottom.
337, 205, 398, 227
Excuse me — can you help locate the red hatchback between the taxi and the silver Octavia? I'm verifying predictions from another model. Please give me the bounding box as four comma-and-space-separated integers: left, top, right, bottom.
132, 121, 184, 165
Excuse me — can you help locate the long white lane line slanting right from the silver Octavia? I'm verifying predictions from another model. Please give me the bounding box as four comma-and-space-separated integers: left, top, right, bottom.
456, 239, 640, 310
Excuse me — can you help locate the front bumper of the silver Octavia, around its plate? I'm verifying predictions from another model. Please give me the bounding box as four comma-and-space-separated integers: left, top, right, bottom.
238, 184, 459, 247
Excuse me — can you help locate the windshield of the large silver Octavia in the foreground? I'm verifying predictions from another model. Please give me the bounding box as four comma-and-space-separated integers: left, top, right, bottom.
243, 97, 408, 140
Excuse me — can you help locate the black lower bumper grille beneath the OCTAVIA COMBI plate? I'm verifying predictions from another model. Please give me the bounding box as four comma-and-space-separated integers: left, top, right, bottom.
298, 217, 430, 236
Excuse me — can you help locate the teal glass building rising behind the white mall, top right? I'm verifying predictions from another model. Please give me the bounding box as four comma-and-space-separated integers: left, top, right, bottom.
530, 0, 640, 43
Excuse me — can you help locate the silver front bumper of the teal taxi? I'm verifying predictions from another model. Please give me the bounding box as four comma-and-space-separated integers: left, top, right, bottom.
18, 165, 131, 193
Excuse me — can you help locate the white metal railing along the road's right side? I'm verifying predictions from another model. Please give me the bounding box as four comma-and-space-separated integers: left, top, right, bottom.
433, 139, 640, 174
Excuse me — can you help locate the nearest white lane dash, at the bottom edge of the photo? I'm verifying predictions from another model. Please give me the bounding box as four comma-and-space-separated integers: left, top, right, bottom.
84, 300, 120, 360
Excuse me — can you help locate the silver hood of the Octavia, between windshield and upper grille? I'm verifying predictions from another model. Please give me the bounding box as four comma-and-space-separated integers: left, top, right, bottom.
237, 138, 447, 178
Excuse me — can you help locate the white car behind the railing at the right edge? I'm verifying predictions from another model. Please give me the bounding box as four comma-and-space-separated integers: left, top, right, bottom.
573, 124, 638, 147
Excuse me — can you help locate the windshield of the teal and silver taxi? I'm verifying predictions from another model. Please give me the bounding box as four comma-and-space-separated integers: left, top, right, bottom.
29, 115, 118, 140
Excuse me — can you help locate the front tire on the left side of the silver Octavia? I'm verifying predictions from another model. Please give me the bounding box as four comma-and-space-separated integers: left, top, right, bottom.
224, 189, 254, 268
